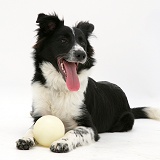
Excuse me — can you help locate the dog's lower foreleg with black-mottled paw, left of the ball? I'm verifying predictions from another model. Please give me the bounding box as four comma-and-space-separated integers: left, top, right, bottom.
16, 126, 35, 150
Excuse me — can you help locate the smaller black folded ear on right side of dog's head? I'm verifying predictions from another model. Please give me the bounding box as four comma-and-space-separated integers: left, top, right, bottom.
76, 22, 94, 38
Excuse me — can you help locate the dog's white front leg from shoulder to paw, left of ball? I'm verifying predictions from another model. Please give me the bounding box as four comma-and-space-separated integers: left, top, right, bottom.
16, 82, 51, 150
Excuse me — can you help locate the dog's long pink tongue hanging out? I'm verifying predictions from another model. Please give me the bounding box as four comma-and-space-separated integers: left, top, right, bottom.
63, 61, 80, 91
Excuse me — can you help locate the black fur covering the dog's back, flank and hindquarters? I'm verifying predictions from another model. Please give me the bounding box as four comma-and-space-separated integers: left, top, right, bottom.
85, 78, 134, 133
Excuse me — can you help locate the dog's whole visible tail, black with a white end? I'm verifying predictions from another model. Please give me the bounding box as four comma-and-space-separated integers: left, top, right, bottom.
132, 107, 160, 121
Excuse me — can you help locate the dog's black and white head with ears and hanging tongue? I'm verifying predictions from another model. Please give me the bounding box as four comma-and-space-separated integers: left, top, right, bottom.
34, 13, 95, 91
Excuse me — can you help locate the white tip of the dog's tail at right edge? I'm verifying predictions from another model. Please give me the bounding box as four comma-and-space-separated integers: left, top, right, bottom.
143, 107, 160, 121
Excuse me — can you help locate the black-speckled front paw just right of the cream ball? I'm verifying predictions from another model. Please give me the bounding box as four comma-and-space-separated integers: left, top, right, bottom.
50, 140, 74, 153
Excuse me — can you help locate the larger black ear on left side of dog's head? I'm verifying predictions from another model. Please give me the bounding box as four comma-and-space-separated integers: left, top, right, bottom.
36, 13, 64, 34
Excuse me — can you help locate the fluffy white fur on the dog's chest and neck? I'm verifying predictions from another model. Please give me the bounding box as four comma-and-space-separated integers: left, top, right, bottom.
31, 62, 88, 131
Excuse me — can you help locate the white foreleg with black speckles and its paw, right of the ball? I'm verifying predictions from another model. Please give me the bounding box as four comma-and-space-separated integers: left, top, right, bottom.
50, 126, 98, 153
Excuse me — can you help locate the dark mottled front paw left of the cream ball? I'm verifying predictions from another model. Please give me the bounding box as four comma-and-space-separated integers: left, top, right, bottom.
16, 138, 35, 150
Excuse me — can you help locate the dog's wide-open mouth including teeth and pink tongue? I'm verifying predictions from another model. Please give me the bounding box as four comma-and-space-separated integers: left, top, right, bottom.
58, 58, 80, 91
